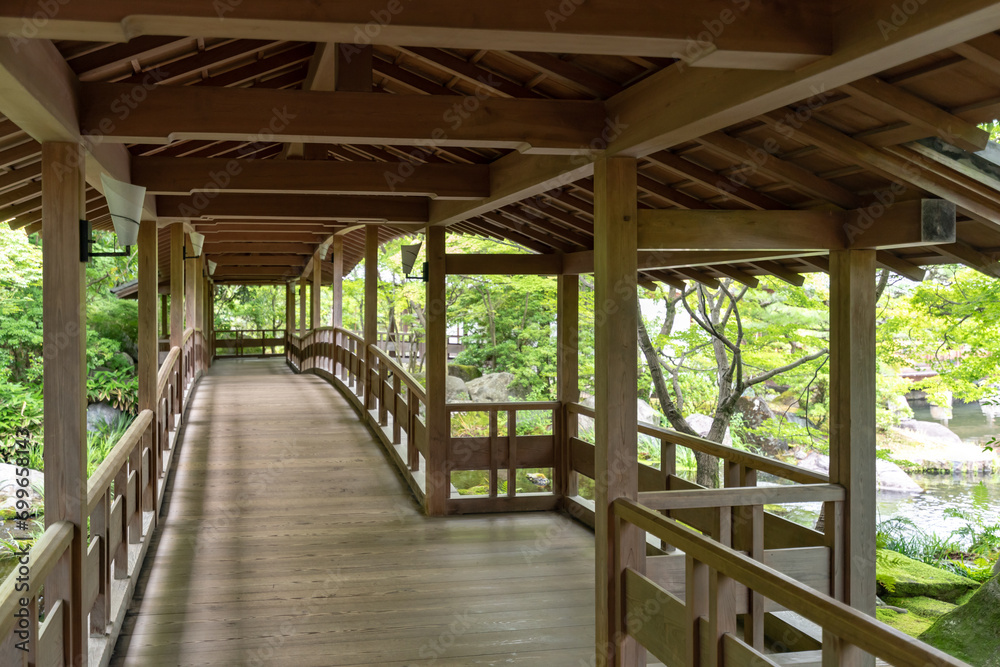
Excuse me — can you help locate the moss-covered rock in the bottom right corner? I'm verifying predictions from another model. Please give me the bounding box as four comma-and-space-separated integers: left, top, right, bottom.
919, 577, 1000, 667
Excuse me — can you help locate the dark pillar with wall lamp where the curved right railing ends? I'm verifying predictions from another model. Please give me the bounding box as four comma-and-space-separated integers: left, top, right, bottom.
424, 227, 451, 516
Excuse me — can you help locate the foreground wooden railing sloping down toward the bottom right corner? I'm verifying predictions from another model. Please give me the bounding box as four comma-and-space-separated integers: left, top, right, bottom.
612, 500, 967, 667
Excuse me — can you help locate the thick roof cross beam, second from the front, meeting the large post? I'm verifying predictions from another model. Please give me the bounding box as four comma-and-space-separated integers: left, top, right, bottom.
80, 83, 605, 153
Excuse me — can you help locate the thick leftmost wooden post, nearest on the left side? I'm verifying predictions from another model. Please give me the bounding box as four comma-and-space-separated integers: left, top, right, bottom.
41, 142, 90, 667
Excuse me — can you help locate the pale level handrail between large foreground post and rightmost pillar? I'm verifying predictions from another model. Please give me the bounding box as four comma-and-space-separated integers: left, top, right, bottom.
639, 484, 847, 510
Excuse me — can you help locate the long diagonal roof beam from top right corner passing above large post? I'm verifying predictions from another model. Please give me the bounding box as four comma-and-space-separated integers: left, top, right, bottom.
431, 0, 1000, 225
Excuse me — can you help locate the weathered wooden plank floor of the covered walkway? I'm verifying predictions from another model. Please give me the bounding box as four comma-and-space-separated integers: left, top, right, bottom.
111, 360, 594, 667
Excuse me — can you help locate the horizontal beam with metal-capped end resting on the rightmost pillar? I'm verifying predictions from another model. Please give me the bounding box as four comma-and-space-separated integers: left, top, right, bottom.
639, 199, 956, 251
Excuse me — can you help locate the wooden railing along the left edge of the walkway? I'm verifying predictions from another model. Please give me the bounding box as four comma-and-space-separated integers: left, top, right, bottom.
0, 330, 207, 665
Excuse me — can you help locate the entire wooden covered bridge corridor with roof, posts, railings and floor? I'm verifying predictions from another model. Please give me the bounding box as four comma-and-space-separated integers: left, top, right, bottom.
0, 0, 1000, 667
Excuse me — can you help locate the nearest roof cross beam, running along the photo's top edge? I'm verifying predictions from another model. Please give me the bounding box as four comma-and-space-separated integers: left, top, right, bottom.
0, 0, 833, 62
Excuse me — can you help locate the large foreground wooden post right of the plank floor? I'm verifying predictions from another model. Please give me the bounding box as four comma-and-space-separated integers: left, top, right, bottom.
594, 158, 645, 667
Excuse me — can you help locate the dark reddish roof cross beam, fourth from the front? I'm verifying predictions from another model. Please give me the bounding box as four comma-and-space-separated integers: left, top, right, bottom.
158, 192, 427, 223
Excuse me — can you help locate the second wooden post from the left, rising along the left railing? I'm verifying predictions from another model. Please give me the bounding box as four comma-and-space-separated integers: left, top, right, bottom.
138, 220, 163, 524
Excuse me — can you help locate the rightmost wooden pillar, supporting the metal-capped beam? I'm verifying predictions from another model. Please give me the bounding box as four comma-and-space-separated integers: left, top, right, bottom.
824, 250, 876, 667
